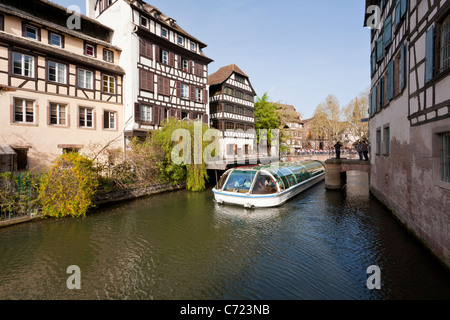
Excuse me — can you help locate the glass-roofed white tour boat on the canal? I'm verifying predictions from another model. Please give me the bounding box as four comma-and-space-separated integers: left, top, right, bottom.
213, 160, 325, 208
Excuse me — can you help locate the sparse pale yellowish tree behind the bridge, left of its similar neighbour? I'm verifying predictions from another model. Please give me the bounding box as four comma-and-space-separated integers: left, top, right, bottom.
311, 95, 345, 143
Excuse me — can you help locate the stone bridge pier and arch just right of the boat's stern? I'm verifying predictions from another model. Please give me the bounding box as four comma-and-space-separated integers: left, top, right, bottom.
325, 159, 370, 190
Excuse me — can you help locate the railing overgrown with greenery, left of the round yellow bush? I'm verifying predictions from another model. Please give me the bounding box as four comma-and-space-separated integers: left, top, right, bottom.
0, 172, 37, 222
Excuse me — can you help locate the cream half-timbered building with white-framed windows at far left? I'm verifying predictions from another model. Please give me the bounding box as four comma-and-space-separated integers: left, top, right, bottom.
0, 0, 124, 171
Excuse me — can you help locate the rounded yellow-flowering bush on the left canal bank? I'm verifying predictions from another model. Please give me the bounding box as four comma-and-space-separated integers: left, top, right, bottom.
38, 153, 99, 218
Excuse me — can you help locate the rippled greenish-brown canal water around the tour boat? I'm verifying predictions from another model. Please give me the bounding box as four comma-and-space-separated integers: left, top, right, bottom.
0, 174, 450, 300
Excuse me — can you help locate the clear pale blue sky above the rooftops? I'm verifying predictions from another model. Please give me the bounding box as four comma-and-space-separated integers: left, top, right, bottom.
53, 0, 370, 118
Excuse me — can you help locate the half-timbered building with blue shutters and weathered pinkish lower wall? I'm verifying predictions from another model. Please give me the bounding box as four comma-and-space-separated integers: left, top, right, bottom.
365, 0, 450, 266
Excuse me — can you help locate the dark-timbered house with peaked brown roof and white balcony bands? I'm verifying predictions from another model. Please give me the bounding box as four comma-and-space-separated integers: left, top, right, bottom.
208, 64, 256, 157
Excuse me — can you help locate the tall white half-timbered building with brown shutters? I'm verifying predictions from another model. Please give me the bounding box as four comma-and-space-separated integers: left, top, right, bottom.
86, 0, 212, 137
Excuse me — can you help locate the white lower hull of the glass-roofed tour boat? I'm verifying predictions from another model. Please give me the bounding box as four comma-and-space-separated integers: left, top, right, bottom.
213, 174, 325, 208
